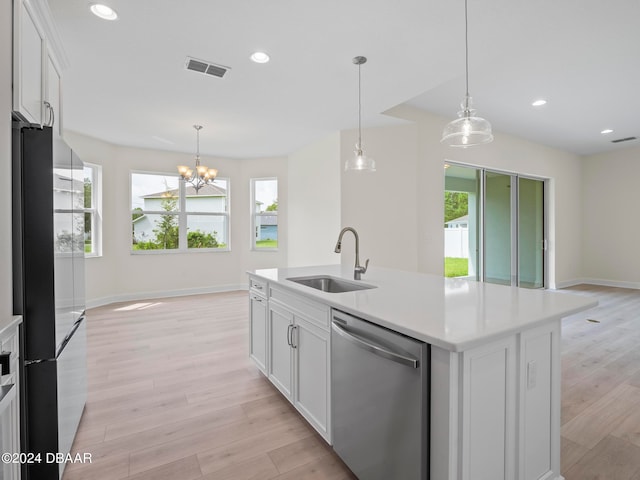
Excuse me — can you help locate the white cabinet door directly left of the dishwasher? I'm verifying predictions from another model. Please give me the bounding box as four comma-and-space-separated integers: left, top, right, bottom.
294, 317, 330, 442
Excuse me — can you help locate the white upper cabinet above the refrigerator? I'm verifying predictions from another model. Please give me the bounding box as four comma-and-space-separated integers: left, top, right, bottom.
13, 0, 65, 136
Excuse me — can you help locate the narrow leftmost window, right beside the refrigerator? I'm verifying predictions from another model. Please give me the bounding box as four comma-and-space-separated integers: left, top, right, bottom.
84, 163, 102, 257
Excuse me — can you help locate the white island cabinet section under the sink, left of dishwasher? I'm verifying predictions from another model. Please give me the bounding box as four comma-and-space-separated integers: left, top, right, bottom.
249, 277, 331, 443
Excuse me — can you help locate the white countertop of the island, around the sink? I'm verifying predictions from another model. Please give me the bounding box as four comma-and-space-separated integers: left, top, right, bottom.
249, 265, 597, 352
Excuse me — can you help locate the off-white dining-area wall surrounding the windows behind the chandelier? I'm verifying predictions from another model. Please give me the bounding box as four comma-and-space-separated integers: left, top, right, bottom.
65, 132, 287, 306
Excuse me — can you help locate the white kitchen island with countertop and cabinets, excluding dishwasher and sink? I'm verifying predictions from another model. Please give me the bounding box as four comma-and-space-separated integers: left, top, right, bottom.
250, 265, 596, 480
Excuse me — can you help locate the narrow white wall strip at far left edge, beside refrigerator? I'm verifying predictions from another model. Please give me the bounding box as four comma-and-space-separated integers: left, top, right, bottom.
0, 2, 13, 322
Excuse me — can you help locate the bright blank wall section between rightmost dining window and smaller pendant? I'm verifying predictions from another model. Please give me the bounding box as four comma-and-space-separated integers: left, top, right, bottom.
288, 132, 341, 267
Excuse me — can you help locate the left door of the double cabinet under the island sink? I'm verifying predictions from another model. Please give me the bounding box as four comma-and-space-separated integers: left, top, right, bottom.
268, 305, 293, 400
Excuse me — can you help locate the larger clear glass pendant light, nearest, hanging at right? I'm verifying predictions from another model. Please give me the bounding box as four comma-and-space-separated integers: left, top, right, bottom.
440, 0, 493, 148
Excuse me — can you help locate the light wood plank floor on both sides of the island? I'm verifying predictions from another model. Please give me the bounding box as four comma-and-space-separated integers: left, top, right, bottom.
64, 286, 640, 480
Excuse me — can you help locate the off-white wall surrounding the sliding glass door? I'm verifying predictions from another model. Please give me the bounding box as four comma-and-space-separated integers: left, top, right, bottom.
341, 106, 582, 287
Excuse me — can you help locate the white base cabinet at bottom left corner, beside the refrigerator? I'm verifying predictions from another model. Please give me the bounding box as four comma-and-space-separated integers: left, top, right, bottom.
0, 317, 20, 480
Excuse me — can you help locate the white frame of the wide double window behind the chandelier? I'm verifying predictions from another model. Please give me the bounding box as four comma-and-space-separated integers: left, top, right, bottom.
129, 170, 231, 255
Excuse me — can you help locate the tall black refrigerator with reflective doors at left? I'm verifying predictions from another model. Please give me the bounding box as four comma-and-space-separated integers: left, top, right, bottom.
12, 120, 87, 480
